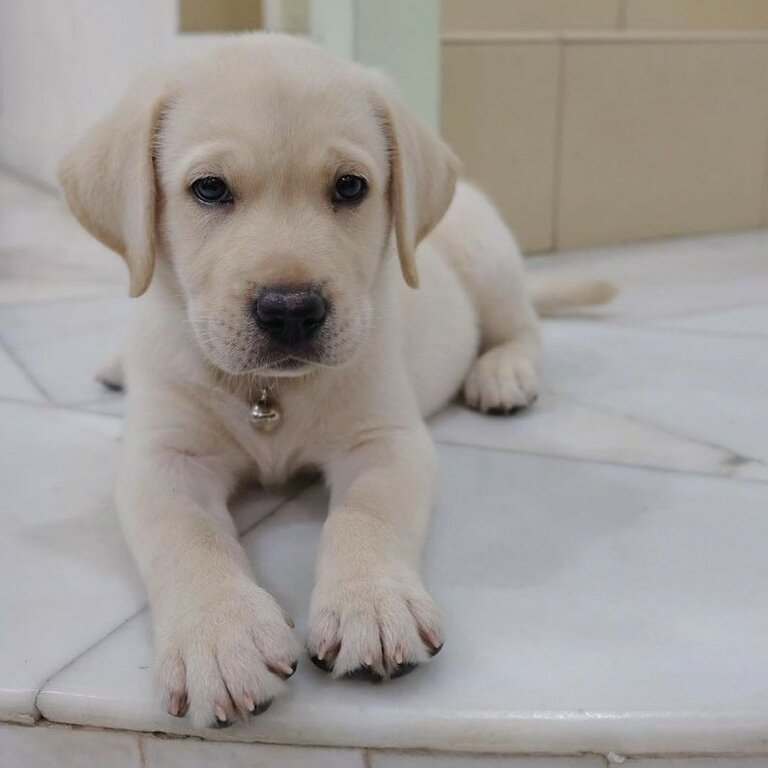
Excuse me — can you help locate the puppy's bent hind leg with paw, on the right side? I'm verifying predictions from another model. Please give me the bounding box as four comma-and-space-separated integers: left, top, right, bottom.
428, 184, 539, 414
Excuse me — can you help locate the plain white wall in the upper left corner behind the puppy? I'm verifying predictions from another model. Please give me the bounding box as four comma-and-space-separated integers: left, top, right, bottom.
0, 0, 222, 184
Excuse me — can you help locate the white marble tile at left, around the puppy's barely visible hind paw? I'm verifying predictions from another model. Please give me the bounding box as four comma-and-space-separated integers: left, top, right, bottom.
0, 298, 132, 405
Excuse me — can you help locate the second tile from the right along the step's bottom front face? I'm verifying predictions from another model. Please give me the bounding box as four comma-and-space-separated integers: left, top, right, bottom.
370, 752, 607, 768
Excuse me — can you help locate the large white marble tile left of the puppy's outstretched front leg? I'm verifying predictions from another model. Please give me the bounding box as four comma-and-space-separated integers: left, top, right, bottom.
0, 403, 144, 721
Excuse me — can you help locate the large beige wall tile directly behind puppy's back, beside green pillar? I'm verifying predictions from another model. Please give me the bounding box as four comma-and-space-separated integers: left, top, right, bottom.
442, 43, 559, 251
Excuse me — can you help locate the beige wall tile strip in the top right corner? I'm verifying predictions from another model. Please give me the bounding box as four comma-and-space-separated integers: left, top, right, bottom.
626, 0, 768, 29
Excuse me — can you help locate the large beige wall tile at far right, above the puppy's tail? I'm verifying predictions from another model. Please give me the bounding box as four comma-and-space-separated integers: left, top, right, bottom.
556, 42, 768, 248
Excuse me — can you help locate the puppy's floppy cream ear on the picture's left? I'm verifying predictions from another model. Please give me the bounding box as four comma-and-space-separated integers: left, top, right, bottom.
59, 77, 166, 297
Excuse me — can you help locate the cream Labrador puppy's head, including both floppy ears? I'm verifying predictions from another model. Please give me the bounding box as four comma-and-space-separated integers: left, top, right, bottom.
60, 35, 457, 375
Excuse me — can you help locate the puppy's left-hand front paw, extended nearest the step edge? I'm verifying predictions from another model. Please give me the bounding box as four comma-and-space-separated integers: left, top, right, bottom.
155, 582, 299, 728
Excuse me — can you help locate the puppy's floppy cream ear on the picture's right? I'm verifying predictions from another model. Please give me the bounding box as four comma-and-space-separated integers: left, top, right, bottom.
375, 76, 459, 288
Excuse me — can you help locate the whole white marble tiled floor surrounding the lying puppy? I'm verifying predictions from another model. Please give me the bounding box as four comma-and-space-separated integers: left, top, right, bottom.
0, 171, 768, 768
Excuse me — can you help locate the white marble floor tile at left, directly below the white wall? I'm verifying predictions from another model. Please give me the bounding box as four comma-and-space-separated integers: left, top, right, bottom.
0, 174, 127, 305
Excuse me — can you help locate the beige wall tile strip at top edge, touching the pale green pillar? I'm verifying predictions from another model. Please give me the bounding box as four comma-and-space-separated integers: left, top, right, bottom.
442, 0, 620, 32
